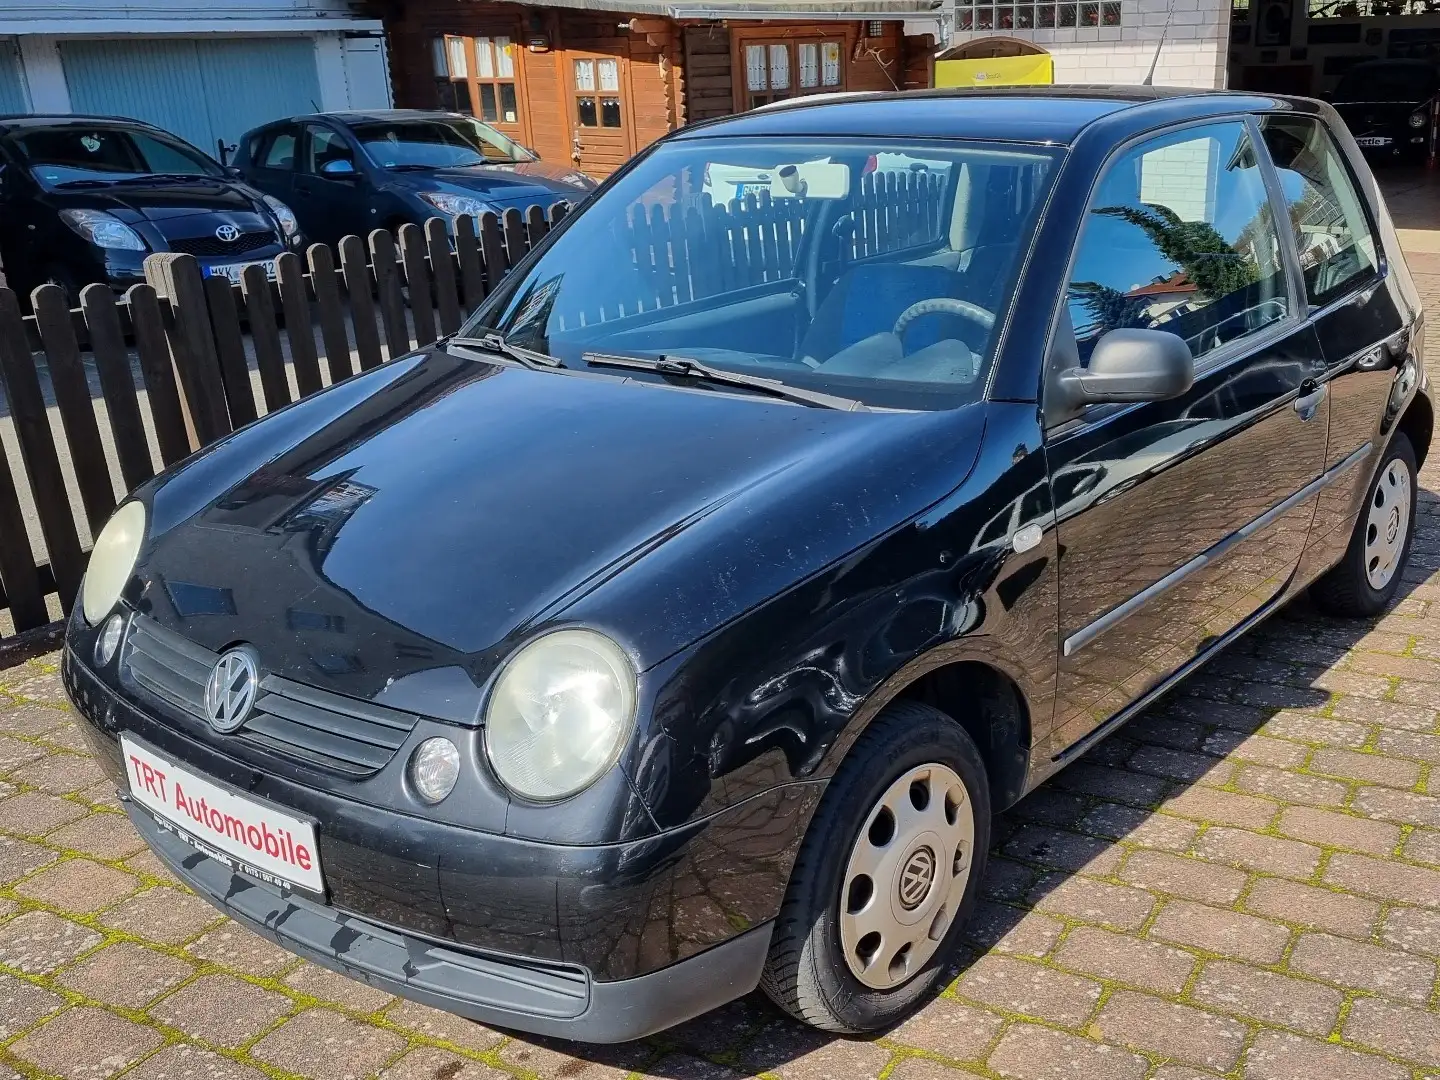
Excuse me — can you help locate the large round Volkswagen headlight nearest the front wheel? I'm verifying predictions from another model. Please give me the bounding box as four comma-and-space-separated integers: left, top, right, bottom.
485, 629, 635, 802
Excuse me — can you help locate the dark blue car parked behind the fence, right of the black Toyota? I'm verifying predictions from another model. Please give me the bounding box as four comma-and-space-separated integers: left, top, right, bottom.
232, 109, 596, 252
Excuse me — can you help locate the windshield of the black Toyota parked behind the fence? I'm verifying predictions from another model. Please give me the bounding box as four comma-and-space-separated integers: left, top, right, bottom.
16, 125, 223, 187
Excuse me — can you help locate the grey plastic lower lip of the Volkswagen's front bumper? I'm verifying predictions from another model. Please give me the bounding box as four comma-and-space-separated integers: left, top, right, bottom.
125, 799, 770, 1043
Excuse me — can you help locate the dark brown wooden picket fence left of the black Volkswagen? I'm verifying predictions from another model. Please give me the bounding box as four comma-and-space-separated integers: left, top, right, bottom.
0, 203, 569, 662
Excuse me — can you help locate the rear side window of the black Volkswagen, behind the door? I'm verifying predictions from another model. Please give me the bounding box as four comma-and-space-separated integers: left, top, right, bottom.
1260, 117, 1380, 312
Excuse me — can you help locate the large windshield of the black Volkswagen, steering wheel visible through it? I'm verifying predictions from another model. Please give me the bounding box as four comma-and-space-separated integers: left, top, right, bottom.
464, 138, 1058, 409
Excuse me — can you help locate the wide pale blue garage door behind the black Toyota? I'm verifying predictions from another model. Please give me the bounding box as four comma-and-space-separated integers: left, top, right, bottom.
60, 36, 320, 156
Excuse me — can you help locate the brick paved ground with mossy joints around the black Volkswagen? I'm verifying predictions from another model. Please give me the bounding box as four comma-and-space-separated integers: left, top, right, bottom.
0, 194, 1440, 1080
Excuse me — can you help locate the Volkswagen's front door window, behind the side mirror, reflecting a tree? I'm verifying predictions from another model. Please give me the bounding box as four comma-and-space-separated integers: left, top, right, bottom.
1067, 121, 1289, 363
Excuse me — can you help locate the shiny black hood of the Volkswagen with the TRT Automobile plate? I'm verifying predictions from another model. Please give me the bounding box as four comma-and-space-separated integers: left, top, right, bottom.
135, 351, 984, 720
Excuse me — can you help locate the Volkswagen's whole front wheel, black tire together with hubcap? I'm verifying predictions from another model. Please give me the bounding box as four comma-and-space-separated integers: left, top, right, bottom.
760, 701, 991, 1034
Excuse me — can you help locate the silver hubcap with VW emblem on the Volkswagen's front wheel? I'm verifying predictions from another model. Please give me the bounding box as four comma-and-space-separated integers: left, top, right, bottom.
840, 765, 975, 989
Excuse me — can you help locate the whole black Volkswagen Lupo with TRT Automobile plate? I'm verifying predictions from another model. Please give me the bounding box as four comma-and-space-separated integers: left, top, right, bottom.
63, 88, 1431, 1041
